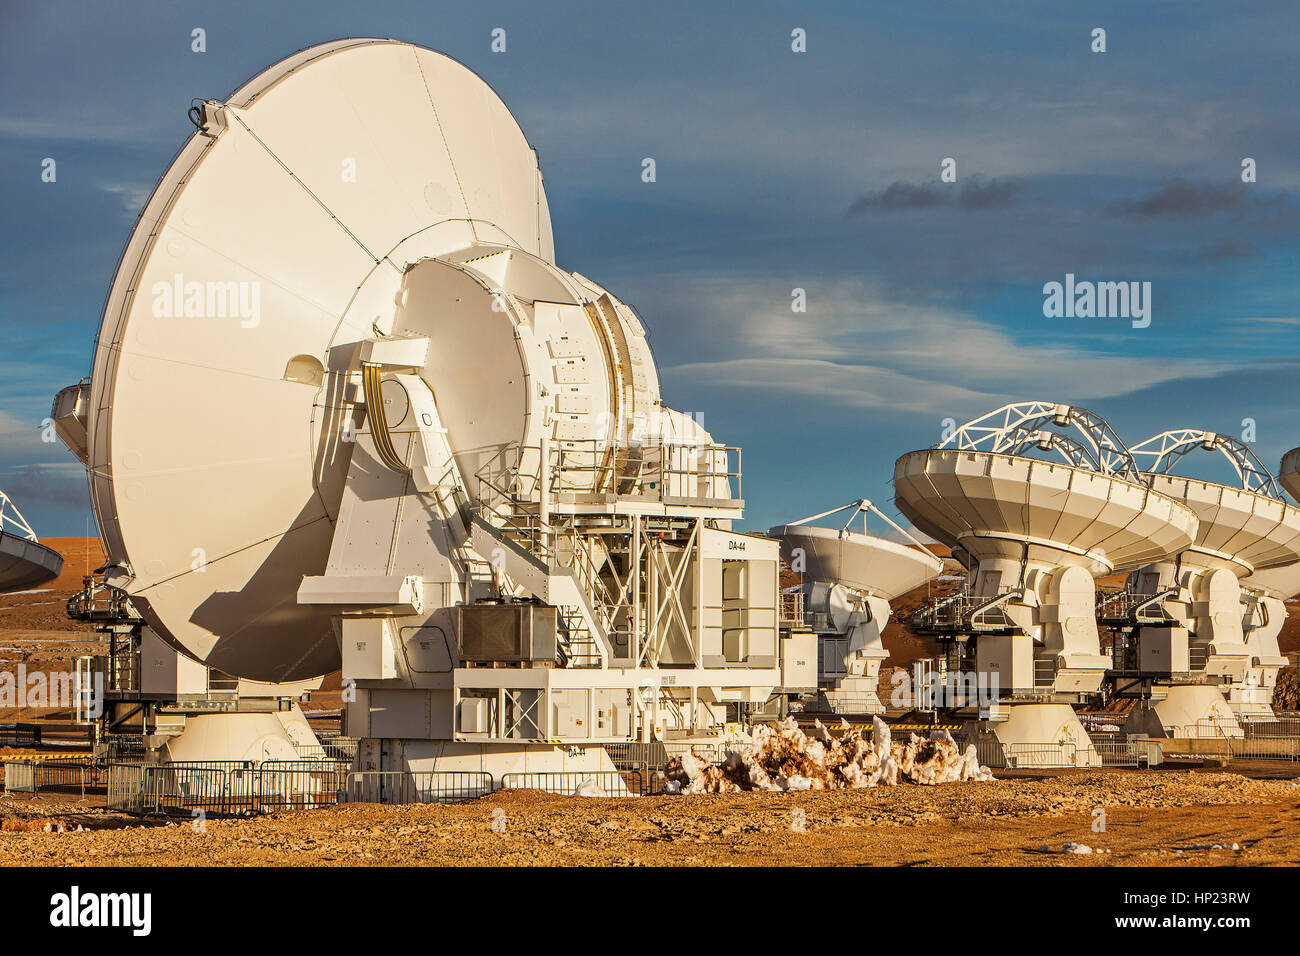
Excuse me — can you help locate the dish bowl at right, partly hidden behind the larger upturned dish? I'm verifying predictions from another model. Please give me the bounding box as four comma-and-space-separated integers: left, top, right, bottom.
1151, 475, 1300, 576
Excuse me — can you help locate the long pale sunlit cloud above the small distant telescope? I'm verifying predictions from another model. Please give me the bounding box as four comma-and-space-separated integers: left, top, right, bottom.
664, 273, 1239, 418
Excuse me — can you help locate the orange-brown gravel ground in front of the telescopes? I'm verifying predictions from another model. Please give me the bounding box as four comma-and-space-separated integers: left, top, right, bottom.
0, 771, 1300, 866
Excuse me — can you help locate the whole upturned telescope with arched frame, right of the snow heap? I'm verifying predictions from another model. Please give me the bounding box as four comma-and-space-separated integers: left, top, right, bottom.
894, 402, 1196, 765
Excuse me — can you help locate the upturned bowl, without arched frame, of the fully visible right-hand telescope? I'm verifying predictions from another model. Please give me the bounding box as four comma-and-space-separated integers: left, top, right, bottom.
894, 449, 1196, 572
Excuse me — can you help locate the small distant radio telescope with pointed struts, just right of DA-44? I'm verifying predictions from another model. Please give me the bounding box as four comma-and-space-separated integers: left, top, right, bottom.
767, 498, 944, 714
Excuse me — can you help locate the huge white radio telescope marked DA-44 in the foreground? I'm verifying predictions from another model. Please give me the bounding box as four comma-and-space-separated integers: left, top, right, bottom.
50, 39, 780, 774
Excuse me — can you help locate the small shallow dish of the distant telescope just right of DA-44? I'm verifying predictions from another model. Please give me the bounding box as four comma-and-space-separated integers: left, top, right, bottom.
767, 524, 944, 601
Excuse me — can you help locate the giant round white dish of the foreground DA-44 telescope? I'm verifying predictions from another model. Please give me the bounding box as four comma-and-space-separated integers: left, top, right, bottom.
77, 39, 554, 682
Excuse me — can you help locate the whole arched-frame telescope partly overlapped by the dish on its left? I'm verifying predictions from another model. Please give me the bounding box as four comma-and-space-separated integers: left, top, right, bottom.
1102, 428, 1300, 736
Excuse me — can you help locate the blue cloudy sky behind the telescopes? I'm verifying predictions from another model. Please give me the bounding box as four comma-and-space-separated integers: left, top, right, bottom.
0, 0, 1300, 536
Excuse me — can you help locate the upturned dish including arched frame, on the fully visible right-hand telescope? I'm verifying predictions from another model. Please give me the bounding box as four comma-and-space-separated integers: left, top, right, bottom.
894, 402, 1196, 576
